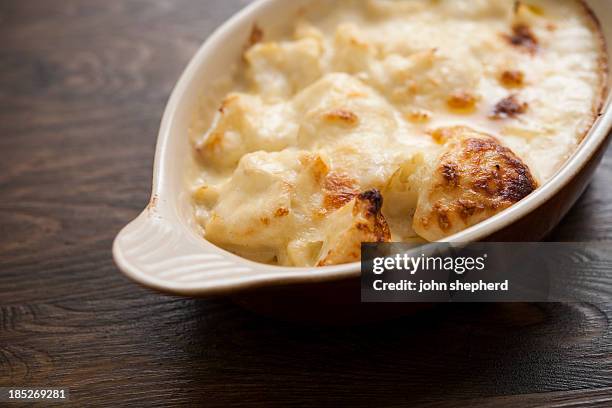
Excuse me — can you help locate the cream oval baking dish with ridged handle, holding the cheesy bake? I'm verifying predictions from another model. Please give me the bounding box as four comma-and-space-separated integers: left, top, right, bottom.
113, 0, 612, 296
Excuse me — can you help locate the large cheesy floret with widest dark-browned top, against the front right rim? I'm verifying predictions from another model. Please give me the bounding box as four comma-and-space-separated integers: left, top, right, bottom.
413, 126, 537, 241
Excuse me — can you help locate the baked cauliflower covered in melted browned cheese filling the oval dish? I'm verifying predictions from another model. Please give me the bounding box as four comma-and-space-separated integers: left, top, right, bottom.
194, 0, 606, 266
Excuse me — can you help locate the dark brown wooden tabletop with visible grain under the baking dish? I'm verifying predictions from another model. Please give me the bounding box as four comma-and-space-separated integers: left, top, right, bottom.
0, 0, 612, 407
